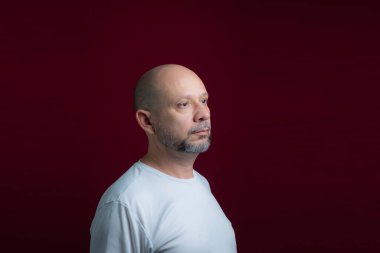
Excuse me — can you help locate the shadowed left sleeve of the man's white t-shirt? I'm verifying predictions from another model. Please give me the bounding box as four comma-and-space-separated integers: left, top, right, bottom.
90, 202, 152, 253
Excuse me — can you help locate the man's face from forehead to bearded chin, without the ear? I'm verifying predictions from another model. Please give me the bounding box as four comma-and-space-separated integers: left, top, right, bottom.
151, 69, 211, 153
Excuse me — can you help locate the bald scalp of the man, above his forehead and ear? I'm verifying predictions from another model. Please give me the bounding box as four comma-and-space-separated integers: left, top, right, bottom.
134, 64, 199, 111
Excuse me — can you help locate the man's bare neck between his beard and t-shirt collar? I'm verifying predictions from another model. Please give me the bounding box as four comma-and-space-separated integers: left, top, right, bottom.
140, 141, 198, 179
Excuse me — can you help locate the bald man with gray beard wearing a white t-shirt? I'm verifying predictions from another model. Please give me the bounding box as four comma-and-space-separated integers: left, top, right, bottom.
90, 64, 236, 253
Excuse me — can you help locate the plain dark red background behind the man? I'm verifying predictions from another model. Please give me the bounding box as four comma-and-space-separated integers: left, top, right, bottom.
0, 1, 380, 253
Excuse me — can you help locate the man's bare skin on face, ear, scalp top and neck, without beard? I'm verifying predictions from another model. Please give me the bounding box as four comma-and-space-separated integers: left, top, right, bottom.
136, 64, 211, 179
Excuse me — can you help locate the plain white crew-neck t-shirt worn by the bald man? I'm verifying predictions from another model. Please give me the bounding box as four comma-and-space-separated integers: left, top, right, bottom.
90, 161, 236, 253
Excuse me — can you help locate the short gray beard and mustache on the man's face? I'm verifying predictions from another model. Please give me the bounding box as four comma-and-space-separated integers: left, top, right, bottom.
156, 123, 211, 154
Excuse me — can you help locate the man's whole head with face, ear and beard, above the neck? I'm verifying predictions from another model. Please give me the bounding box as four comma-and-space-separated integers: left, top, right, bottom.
135, 64, 211, 154
